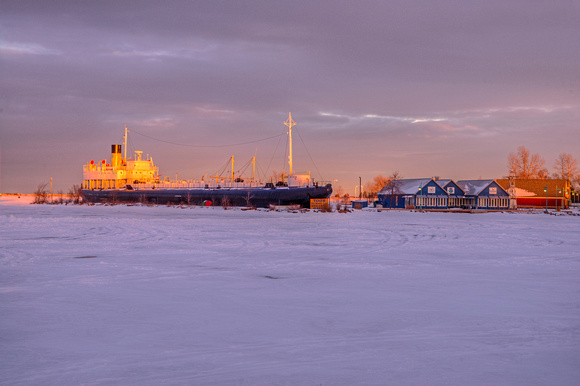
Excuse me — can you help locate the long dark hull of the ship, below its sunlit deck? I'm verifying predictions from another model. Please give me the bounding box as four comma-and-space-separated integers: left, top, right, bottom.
82, 184, 332, 208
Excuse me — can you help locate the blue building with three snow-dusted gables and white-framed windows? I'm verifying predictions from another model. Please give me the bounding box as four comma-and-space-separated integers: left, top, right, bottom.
377, 178, 509, 210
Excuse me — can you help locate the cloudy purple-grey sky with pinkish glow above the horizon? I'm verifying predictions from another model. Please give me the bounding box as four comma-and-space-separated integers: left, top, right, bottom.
0, 0, 580, 194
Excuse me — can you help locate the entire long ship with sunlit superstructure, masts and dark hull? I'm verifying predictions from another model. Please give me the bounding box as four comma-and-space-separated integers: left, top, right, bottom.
81, 113, 332, 208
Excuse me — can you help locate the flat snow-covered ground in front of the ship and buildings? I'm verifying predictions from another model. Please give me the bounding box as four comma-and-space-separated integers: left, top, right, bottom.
0, 197, 580, 385
